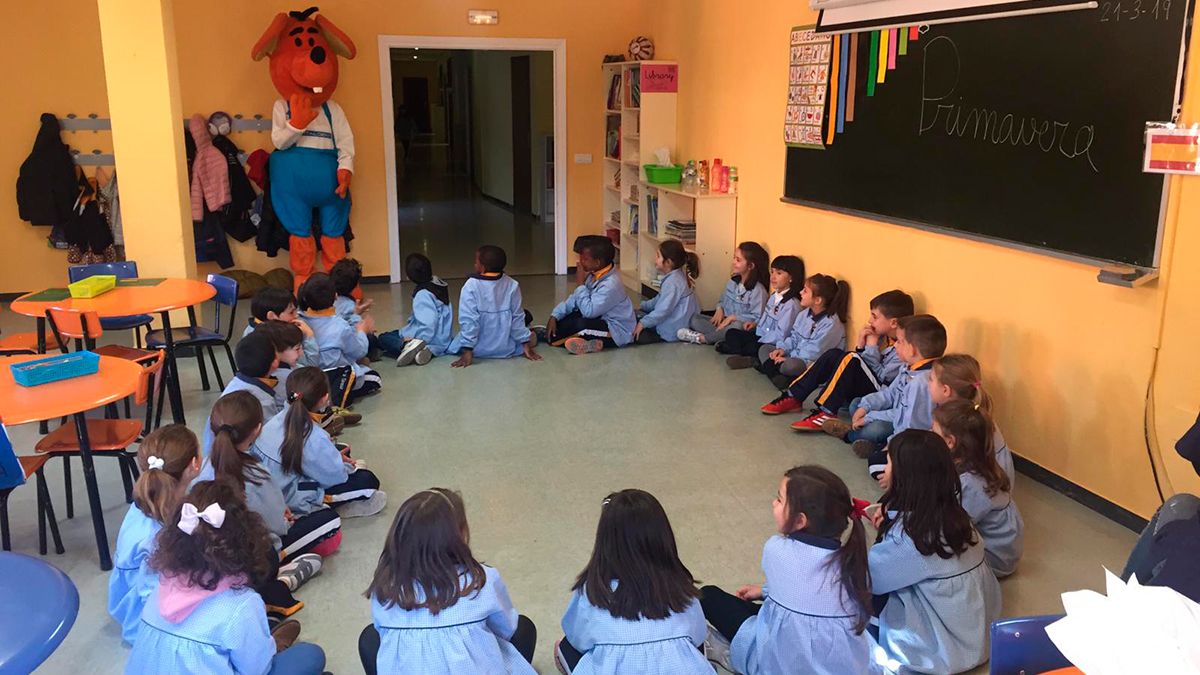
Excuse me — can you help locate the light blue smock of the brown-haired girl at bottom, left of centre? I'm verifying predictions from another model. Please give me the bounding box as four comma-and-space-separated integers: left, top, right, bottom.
371, 566, 536, 675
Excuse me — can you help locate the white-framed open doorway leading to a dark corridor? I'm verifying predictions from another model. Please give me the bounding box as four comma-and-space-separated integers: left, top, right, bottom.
379, 36, 566, 282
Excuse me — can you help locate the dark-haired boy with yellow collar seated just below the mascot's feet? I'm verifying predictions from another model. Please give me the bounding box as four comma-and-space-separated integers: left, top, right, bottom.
300, 271, 383, 407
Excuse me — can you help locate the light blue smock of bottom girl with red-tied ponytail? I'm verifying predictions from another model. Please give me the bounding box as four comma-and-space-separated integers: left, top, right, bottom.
730, 533, 872, 675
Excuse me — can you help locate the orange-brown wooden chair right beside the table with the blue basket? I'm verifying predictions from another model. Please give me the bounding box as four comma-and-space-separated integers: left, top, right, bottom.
34, 351, 166, 518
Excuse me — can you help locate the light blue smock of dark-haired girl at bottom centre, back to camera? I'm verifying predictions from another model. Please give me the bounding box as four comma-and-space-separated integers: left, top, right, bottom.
563, 581, 713, 675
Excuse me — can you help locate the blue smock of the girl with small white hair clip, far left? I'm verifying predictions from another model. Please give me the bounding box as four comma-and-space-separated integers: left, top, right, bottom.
108, 506, 162, 645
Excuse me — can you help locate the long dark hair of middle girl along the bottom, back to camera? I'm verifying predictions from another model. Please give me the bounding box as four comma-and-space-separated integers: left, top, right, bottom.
571, 490, 700, 621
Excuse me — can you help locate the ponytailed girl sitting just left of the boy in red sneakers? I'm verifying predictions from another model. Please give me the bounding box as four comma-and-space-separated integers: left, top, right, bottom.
758, 274, 850, 389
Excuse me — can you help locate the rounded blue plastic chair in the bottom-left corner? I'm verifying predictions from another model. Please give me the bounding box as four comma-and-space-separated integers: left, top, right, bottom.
0, 552, 79, 673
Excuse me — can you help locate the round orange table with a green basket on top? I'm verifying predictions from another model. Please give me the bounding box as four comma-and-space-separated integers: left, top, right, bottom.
11, 279, 217, 424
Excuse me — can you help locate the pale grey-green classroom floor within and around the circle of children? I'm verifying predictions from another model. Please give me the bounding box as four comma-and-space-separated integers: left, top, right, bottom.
0, 275, 1135, 675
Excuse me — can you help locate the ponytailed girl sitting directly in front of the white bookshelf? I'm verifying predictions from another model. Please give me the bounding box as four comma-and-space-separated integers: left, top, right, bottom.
634, 239, 700, 345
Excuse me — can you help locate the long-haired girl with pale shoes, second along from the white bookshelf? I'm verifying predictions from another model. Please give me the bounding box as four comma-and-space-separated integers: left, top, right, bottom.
679, 241, 770, 345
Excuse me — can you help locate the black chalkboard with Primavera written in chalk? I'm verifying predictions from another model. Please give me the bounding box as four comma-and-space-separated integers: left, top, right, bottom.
784, 5, 1192, 267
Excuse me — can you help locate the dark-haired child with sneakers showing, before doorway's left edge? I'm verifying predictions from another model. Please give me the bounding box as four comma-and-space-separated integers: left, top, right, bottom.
379, 253, 454, 366
